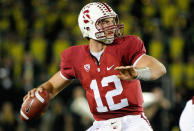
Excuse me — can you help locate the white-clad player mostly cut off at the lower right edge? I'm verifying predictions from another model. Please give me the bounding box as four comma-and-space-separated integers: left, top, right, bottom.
179, 97, 194, 131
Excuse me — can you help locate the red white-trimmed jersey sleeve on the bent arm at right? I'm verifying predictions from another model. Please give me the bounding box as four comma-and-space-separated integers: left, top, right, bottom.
129, 36, 146, 65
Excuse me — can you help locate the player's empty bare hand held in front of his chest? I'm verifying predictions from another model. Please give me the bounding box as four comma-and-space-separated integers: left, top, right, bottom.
115, 66, 137, 80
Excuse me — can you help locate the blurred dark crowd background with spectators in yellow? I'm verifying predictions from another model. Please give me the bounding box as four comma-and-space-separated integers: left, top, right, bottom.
0, 0, 194, 131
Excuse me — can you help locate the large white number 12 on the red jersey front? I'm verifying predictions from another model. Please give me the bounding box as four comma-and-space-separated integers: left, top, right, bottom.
90, 75, 129, 112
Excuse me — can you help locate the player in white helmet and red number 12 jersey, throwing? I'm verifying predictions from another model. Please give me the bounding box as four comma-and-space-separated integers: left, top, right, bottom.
24, 2, 166, 131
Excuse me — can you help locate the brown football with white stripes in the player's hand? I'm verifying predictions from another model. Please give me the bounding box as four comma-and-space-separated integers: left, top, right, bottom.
20, 91, 50, 121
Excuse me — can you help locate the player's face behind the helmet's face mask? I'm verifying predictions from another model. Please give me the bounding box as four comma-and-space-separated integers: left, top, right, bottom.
98, 18, 116, 38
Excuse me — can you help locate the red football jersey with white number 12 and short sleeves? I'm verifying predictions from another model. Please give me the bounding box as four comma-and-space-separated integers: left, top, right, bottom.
60, 36, 146, 120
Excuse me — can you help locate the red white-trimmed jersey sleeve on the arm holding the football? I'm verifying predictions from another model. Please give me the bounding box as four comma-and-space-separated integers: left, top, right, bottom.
60, 48, 75, 79
